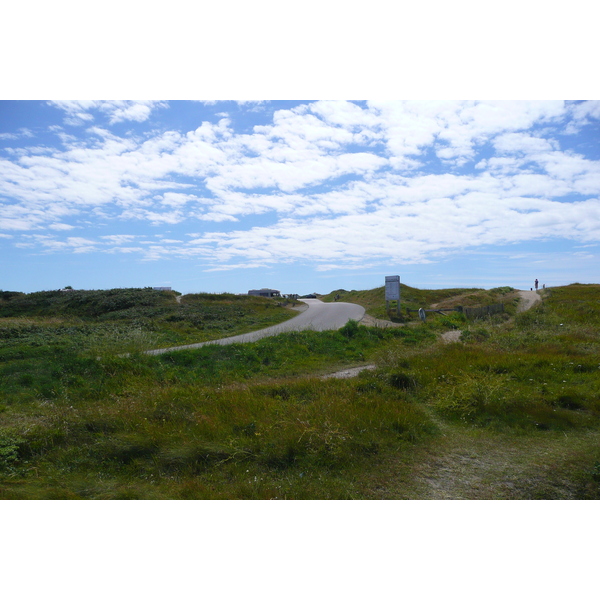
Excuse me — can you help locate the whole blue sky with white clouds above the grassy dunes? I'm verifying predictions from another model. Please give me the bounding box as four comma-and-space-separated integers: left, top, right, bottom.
0, 100, 600, 294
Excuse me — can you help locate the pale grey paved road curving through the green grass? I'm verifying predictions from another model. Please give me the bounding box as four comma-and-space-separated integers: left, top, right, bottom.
146, 299, 365, 354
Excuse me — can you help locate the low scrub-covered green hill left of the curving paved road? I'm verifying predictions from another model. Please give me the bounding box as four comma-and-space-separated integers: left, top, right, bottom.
0, 288, 296, 352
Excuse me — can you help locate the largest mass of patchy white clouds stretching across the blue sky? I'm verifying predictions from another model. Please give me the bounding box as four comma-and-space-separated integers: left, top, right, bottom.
0, 101, 600, 271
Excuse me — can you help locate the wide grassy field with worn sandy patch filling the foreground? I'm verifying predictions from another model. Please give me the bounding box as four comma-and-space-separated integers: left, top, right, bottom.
0, 284, 600, 499
